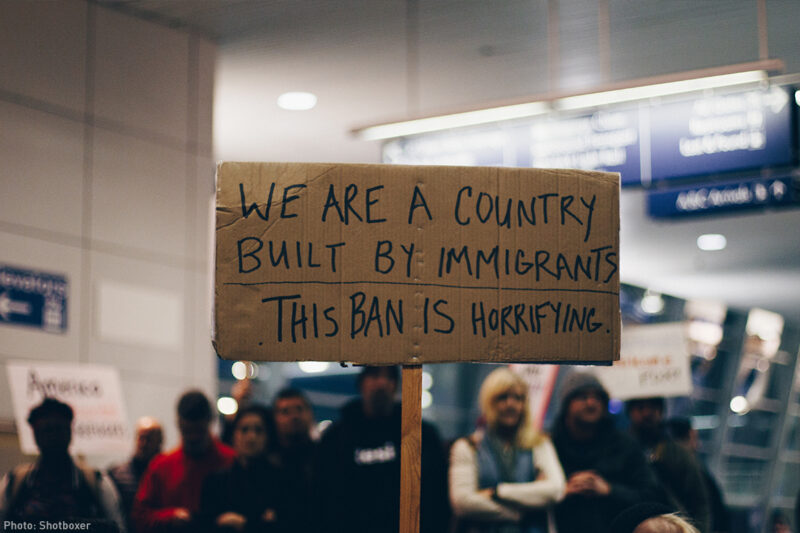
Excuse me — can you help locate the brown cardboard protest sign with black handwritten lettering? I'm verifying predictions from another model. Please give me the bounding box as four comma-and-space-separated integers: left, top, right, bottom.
214, 163, 620, 364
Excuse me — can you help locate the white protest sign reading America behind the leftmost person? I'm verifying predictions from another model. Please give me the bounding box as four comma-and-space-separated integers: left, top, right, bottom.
7, 361, 130, 455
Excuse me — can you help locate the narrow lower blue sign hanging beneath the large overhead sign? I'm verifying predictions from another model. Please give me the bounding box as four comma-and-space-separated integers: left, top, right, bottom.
647, 177, 800, 218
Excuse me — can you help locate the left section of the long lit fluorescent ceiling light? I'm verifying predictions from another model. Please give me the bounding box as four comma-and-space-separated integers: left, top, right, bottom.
355, 102, 550, 141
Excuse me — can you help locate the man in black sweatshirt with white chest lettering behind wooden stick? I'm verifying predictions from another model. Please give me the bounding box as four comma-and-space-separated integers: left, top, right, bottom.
316, 366, 450, 533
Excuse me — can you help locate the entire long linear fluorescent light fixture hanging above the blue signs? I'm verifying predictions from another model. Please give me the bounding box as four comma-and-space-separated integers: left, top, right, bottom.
352, 59, 784, 141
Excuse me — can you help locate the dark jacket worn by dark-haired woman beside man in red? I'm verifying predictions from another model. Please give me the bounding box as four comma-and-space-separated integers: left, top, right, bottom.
200, 458, 293, 533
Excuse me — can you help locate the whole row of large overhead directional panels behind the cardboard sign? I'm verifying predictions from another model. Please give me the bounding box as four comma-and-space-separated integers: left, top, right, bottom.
383, 86, 797, 186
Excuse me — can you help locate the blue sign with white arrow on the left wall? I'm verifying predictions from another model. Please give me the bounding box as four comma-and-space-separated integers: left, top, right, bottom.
0, 265, 67, 333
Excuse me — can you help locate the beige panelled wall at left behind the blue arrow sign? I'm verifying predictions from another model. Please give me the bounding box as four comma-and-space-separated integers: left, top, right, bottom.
0, 0, 216, 458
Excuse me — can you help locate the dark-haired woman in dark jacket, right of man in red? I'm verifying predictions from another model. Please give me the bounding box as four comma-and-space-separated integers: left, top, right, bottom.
200, 404, 288, 533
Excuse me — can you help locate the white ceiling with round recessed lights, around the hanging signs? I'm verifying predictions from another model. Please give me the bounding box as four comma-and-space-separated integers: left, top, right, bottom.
104, 0, 800, 325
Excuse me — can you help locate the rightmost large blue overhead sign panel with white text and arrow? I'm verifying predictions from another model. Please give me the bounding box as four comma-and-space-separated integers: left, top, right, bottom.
650, 87, 792, 181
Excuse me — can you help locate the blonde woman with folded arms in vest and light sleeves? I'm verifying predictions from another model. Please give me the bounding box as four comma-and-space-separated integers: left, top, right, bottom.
450, 367, 566, 533
